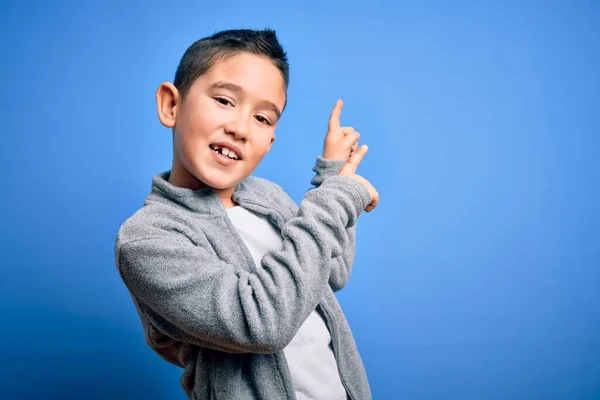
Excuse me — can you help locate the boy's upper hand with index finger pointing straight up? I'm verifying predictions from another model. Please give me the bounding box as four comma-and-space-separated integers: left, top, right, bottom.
323, 100, 360, 161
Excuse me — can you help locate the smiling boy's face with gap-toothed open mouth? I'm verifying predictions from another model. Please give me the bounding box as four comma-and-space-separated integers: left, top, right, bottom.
174, 53, 286, 190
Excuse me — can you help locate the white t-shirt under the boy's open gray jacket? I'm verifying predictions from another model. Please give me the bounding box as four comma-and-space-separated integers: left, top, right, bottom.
227, 206, 347, 400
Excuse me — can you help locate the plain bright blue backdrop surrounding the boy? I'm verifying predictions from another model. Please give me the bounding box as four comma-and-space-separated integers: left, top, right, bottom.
0, 0, 600, 400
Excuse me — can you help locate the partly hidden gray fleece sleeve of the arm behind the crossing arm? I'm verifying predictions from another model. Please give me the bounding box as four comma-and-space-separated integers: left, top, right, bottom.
311, 157, 370, 292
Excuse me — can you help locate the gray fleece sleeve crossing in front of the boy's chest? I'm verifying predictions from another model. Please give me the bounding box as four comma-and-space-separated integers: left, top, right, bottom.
116, 177, 369, 353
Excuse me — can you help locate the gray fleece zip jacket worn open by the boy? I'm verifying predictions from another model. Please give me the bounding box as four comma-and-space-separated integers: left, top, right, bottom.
115, 157, 371, 400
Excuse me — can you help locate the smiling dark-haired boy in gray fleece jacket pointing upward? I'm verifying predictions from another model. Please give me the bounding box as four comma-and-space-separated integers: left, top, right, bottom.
115, 30, 378, 400
